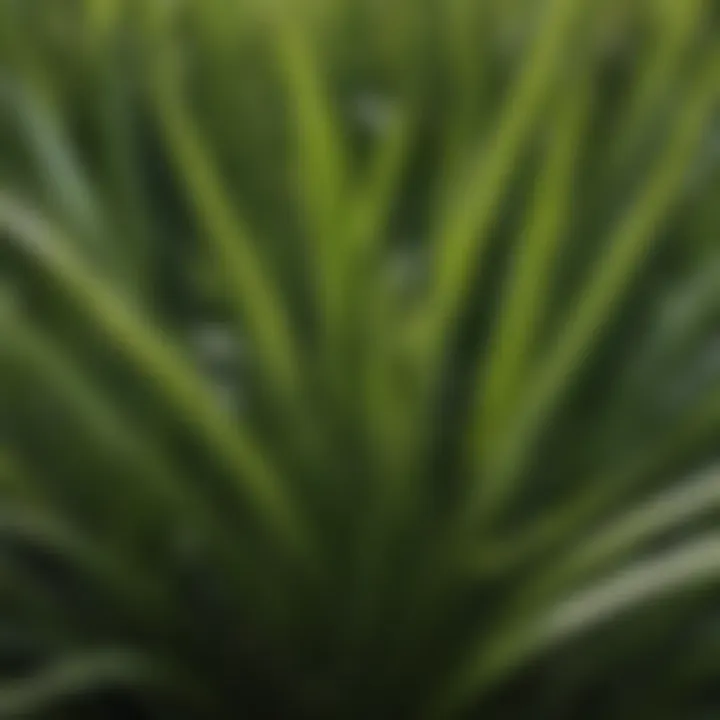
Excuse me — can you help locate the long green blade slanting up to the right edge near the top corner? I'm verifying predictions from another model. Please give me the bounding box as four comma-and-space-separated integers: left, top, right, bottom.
470, 46, 720, 528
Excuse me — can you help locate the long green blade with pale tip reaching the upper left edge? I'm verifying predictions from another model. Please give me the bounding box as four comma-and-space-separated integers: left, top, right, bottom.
0, 195, 316, 568
